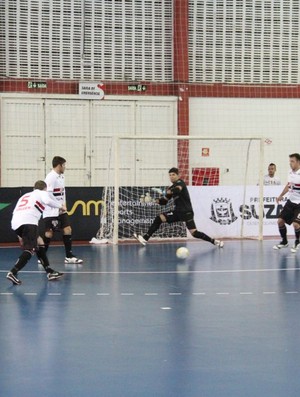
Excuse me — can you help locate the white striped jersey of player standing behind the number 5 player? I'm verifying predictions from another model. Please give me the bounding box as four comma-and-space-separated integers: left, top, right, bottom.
43, 170, 66, 218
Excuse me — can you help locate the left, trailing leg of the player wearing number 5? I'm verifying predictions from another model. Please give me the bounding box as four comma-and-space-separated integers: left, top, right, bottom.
6, 225, 37, 285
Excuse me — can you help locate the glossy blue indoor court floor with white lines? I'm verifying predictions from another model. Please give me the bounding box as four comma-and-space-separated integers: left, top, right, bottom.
0, 241, 300, 397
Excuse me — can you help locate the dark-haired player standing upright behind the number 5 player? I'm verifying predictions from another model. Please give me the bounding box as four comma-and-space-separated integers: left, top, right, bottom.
43, 156, 83, 263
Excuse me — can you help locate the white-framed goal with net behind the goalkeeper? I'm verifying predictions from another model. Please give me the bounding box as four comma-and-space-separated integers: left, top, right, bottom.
92, 136, 264, 243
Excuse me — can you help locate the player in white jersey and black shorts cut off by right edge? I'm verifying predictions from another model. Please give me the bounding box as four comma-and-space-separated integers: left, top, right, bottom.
273, 153, 300, 253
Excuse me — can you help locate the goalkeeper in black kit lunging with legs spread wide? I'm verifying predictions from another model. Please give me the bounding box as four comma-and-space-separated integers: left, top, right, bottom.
134, 167, 224, 248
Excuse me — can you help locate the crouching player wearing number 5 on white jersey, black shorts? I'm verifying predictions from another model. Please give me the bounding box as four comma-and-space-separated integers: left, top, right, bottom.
6, 181, 66, 285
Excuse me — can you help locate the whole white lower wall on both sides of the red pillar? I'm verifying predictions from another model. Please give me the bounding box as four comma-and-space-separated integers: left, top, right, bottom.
0, 94, 300, 186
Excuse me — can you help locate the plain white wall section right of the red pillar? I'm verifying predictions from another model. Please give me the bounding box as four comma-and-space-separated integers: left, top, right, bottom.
190, 98, 300, 185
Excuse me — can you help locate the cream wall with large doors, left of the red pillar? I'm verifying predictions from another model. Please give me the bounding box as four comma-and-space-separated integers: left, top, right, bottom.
0, 94, 177, 187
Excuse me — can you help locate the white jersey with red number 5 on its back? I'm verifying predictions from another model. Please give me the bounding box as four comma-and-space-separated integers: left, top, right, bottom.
11, 189, 62, 230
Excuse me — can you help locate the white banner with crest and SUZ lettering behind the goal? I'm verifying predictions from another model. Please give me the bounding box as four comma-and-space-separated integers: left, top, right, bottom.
189, 186, 293, 237
